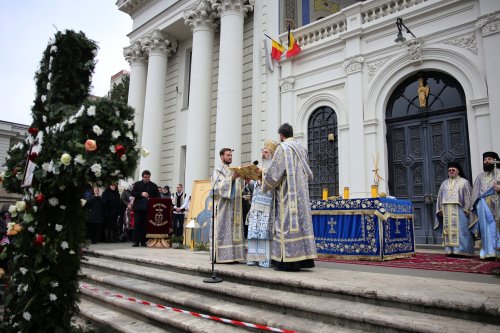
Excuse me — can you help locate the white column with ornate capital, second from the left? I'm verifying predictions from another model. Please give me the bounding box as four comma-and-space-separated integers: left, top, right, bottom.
140, 30, 177, 183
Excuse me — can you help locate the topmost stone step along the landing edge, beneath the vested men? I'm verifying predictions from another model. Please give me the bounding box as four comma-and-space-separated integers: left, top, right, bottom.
84, 249, 500, 325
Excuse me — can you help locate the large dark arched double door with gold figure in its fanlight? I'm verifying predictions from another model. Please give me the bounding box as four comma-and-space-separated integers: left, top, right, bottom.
386, 72, 471, 244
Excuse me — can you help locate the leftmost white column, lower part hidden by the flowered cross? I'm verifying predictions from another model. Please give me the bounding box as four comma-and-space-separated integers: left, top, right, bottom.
123, 41, 148, 147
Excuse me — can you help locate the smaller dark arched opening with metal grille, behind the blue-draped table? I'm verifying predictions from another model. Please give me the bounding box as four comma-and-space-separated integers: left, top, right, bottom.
307, 106, 339, 200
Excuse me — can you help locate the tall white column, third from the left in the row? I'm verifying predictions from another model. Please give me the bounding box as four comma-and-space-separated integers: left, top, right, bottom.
184, 0, 216, 193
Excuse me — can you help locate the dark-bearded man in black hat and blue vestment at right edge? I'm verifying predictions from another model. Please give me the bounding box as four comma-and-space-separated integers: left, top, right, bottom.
470, 152, 500, 259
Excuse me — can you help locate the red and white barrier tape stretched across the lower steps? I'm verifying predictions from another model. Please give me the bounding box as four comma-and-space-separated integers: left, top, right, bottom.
80, 283, 297, 333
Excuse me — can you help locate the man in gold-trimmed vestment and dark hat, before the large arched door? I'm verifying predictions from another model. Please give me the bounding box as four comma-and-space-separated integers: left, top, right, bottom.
434, 162, 474, 256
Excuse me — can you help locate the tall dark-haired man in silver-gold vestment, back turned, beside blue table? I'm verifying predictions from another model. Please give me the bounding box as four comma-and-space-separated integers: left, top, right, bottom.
262, 123, 317, 271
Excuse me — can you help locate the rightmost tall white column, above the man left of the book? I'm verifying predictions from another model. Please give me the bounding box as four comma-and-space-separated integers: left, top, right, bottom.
211, 0, 253, 165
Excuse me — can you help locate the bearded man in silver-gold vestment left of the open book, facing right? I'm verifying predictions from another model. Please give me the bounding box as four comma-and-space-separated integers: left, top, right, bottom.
210, 148, 245, 263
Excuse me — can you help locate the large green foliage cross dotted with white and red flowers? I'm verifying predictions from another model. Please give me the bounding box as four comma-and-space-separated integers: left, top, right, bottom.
0, 31, 139, 332
